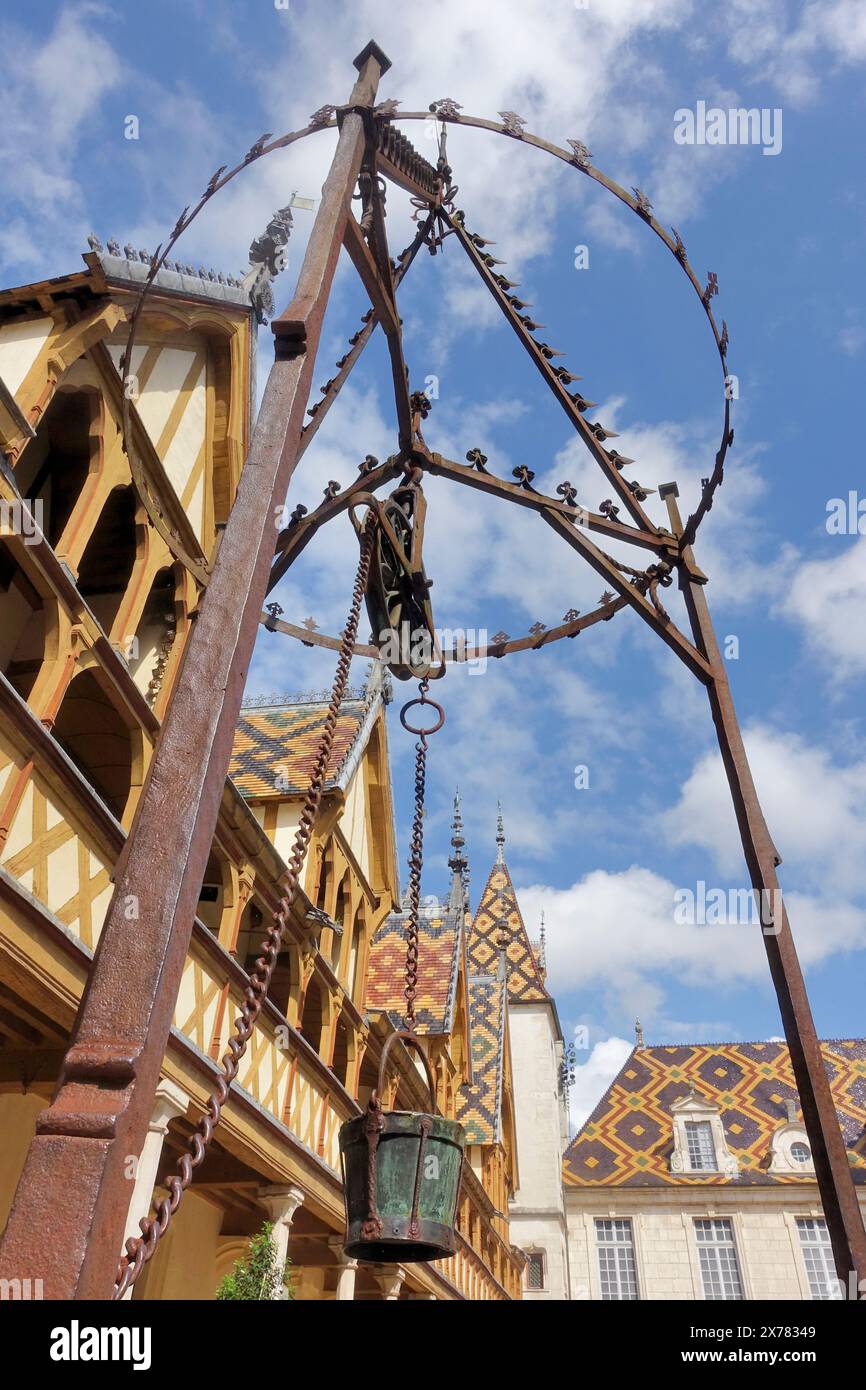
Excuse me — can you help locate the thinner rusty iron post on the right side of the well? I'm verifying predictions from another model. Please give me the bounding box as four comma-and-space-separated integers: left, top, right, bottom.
659, 484, 866, 1290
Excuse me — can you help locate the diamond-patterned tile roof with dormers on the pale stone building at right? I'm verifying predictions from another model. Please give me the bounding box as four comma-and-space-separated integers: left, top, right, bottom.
563, 1038, 866, 1187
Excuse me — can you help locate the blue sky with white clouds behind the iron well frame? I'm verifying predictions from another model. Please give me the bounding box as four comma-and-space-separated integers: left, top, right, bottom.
0, 0, 866, 1113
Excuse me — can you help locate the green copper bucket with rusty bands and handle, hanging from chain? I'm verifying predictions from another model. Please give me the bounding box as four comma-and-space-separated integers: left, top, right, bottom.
339, 1033, 464, 1265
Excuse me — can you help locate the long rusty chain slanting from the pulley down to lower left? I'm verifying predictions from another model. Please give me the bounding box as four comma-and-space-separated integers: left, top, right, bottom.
114, 512, 377, 1300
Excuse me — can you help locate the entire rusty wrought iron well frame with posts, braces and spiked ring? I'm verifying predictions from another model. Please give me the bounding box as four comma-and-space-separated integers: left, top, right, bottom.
0, 42, 866, 1298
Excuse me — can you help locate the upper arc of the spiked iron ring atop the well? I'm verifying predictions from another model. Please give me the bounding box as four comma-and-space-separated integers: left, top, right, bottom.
120, 99, 734, 589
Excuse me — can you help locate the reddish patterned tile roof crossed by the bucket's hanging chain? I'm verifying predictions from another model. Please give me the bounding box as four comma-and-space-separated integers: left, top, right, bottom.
366, 906, 463, 1034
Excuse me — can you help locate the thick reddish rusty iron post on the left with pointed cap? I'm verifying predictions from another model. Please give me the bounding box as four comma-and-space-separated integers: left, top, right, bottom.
0, 43, 391, 1298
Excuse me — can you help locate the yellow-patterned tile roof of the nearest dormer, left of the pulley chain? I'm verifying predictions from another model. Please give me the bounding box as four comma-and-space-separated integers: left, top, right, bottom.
228, 699, 371, 799
